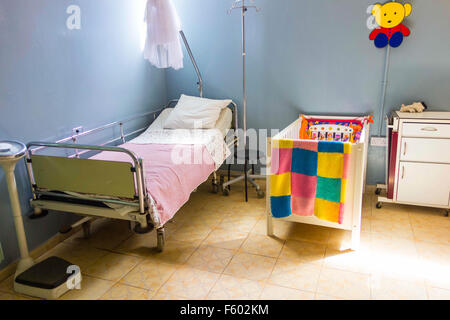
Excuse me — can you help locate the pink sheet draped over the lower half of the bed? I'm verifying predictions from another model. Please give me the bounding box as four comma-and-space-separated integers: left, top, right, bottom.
91, 143, 215, 225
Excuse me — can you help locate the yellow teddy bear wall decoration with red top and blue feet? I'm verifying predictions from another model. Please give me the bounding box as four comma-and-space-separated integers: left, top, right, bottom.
369, 1, 412, 48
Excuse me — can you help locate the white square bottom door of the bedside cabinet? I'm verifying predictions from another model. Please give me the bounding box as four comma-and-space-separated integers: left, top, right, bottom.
397, 161, 450, 206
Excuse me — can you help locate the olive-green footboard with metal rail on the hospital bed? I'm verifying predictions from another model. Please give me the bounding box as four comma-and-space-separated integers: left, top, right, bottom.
26, 142, 145, 214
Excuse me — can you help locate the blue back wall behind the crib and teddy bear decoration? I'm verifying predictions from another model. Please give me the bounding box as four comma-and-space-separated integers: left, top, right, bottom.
167, 0, 450, 184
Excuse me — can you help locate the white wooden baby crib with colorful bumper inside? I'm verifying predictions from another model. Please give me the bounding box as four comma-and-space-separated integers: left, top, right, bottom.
266, 115, 371, 250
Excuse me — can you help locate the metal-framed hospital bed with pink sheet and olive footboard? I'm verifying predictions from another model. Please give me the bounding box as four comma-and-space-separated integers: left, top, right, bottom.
26, 100, 238, 251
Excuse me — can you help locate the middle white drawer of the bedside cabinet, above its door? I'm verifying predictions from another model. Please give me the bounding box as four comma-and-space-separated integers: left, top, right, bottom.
400, 138, 450, 163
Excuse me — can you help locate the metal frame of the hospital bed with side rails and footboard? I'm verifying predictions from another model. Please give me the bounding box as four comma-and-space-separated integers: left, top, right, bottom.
25, 100, 239, 252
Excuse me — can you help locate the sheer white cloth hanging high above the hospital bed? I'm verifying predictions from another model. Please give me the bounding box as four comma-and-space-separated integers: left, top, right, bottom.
144, 0, 183, 70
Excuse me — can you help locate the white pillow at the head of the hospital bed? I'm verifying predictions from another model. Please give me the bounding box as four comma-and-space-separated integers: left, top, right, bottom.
164, 94, 231, 129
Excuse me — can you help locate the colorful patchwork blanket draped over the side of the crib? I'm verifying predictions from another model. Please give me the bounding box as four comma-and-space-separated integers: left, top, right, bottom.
270, 140, 351, 224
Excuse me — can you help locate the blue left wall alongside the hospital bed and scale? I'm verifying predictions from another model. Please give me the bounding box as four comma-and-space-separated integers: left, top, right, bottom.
0, 0, 167, 269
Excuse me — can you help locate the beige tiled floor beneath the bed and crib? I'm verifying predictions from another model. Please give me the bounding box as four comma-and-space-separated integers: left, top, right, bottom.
0, 184, 450, 300
